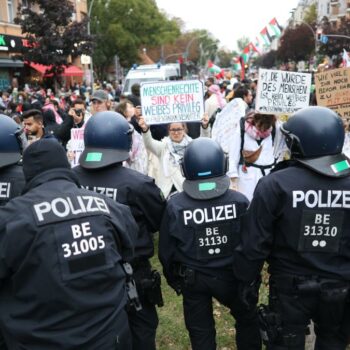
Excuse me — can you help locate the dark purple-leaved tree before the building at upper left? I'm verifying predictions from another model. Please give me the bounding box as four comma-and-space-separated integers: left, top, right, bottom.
15, 0, 93, 78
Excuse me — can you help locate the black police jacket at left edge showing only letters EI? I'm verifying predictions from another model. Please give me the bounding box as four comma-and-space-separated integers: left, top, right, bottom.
0, 165, 25, 206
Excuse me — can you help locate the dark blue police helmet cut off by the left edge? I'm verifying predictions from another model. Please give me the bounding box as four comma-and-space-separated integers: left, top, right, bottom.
0, 114, 22, 168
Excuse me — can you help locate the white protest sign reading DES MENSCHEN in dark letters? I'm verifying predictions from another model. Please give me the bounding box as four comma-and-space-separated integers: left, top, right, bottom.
255, 69, 311, 114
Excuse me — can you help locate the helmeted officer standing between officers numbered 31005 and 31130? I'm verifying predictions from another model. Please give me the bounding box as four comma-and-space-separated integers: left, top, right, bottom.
74, 111, 165, 350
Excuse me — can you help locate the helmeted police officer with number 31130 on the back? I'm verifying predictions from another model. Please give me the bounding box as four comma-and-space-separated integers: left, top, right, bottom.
159, 138, 261, 350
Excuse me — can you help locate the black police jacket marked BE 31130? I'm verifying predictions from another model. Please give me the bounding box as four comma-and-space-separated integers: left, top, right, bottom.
159, 189, 249, 285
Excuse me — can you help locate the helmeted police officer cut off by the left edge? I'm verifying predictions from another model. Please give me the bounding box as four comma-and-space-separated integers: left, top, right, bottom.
0, 114, 24, 206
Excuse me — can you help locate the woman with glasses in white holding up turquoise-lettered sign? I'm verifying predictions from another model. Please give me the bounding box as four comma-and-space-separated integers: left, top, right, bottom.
139, 114, 210, 198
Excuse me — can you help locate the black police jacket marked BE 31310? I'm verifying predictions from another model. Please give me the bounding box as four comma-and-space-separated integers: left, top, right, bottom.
234, 162, 350, 281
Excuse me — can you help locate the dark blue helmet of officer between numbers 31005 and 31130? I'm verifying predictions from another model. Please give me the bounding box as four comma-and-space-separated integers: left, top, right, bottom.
79, 111, 134, 169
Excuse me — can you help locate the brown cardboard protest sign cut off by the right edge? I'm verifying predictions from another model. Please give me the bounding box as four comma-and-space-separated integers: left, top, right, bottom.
315, 68, 350, 118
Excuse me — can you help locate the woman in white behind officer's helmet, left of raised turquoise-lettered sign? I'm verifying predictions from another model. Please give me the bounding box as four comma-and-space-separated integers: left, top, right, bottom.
116, 100, 148, 175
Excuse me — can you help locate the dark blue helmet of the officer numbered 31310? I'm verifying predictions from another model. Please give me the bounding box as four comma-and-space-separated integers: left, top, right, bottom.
281, 106, 350, 177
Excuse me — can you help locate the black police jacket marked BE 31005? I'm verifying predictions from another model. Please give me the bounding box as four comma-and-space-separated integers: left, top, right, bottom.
0, 169, 137, 350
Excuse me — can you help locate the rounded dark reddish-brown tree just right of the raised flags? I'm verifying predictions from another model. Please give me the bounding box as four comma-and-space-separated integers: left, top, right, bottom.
277, 24, 315, 63
